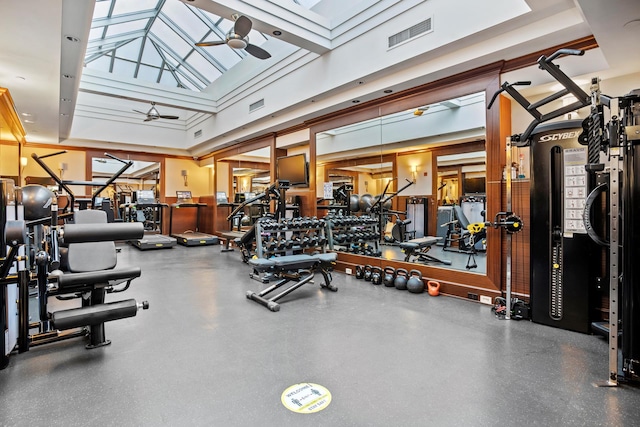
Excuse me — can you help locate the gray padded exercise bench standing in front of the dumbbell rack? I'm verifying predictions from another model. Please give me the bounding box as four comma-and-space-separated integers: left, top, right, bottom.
247, 253, 338, 311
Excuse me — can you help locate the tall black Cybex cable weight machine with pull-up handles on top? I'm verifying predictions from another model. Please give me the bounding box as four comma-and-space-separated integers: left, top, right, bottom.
492, 49, 640, 386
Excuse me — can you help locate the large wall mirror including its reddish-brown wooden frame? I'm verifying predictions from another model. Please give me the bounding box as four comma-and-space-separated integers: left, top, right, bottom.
311, 67, 508, 290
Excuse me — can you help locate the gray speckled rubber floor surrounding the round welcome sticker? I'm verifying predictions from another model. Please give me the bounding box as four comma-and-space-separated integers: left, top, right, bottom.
0, 246, 640, 426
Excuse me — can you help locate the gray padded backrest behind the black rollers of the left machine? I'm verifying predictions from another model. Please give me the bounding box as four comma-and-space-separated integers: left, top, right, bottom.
67, 210, 116, 273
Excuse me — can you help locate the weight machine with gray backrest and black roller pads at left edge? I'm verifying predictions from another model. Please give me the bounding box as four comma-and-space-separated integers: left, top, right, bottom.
0, 180, 149, 369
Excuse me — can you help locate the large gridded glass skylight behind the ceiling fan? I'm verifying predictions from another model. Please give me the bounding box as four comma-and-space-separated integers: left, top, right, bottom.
85, 0, 268, 91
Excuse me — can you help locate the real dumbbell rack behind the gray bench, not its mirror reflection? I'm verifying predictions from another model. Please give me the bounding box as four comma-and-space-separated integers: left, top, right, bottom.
256, 217, 327, 258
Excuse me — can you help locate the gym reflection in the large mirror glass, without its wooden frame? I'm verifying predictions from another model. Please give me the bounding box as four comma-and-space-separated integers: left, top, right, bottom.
316, 92, 487, 274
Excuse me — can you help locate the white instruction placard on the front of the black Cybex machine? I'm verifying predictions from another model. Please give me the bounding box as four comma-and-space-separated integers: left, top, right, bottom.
563, 147, 589, 237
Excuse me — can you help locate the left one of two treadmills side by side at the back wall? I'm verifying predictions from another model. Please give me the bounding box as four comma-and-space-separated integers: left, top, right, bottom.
129, 190, 177, 251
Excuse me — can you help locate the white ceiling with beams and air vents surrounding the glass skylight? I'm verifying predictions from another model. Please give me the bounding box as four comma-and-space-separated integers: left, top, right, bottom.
0, 0, 640, 154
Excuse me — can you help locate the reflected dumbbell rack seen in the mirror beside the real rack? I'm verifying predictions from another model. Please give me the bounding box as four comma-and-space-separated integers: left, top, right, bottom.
325, 215, 381, 256
